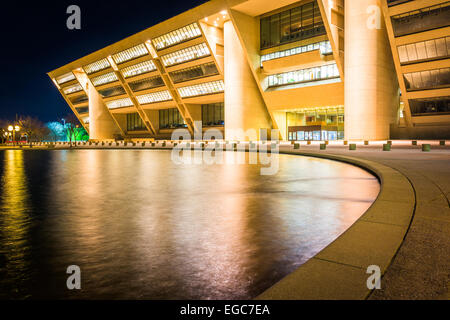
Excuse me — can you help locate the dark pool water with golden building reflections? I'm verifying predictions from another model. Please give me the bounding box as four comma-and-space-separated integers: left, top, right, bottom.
0, 150, 379, 299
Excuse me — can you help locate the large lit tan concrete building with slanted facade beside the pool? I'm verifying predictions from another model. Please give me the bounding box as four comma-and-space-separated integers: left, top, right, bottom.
48, 0, 450, 141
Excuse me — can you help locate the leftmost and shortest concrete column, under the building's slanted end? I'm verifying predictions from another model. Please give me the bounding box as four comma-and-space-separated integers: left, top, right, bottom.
88, 85, 120, 140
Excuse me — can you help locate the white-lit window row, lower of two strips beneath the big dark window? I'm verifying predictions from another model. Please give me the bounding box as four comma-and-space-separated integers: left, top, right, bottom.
268, 63, 339, 87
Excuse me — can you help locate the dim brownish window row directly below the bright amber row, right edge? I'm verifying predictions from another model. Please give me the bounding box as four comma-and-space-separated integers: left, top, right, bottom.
403, 68, 450, 91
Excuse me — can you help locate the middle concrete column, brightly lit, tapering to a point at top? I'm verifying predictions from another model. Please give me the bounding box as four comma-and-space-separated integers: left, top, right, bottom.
224, 21, 272, 141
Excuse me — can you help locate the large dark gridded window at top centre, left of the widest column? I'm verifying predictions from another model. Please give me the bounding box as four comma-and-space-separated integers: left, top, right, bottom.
260, 1, 326, 49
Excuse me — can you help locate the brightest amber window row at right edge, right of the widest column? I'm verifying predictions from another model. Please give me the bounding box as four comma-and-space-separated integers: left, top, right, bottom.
397, 37, 450, 63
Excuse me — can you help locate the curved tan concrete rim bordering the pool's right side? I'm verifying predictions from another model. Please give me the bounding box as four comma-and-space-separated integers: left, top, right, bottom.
256, 151, 416, 300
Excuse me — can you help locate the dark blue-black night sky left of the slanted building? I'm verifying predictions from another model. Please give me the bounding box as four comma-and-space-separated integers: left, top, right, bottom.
0, 0, 206, 122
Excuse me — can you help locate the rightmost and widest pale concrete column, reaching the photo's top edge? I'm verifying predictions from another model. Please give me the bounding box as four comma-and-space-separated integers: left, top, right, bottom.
345, 0, 399, 140
